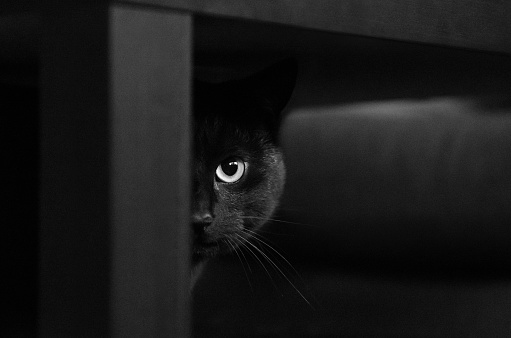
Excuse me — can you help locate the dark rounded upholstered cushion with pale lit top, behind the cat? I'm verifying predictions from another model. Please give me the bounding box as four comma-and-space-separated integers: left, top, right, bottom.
282, 98, 511, 265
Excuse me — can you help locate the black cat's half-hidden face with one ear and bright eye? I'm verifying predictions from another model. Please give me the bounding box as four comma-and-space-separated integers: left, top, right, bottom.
191, 61, 296, 264
